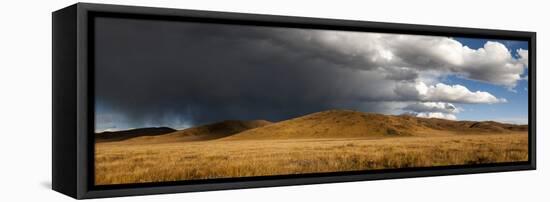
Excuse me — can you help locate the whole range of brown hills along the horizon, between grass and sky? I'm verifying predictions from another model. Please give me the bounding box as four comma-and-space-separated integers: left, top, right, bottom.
96, 110, 528, 143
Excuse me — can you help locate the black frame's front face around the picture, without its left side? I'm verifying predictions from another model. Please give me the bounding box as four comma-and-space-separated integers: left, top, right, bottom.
69, 3, 536, 199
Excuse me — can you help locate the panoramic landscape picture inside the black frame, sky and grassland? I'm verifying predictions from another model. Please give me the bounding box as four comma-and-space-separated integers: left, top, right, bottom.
93, 17, 529, 185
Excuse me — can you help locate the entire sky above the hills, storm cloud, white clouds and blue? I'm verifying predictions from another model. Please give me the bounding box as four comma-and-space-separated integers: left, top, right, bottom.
94, 17, 529, 132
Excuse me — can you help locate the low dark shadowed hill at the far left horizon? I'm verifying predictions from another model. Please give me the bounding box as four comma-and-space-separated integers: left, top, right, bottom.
95, 127, 176, 142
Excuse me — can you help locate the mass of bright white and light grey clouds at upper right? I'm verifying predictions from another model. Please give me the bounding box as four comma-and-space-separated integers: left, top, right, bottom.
252, 30, 528, 119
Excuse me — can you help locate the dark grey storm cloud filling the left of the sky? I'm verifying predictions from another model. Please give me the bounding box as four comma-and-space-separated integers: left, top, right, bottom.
95, 18, 391, 128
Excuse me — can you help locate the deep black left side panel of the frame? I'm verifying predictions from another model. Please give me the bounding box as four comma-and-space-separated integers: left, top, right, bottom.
52, 5, 78, 198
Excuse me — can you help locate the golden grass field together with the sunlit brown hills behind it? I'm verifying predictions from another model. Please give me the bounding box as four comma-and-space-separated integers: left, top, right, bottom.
95, 109, 528, 185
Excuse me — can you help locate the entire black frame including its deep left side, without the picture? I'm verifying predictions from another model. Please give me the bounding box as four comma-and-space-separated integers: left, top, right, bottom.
52, 3, 536, 199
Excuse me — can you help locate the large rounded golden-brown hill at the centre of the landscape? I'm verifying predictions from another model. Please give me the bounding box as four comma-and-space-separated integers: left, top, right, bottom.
224, 110, 419, 140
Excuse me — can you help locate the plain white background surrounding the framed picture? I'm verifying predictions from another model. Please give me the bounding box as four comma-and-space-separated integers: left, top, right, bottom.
0, 0, 550, 202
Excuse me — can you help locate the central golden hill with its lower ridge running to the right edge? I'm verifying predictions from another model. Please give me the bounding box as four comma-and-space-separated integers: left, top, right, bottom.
222, 110, 527, 140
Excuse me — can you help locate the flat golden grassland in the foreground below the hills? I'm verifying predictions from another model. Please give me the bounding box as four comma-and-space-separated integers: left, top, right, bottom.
95, 132, 528, 185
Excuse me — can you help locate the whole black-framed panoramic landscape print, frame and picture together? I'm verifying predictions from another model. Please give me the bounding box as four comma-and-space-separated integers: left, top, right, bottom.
52, 3, 536, 198
